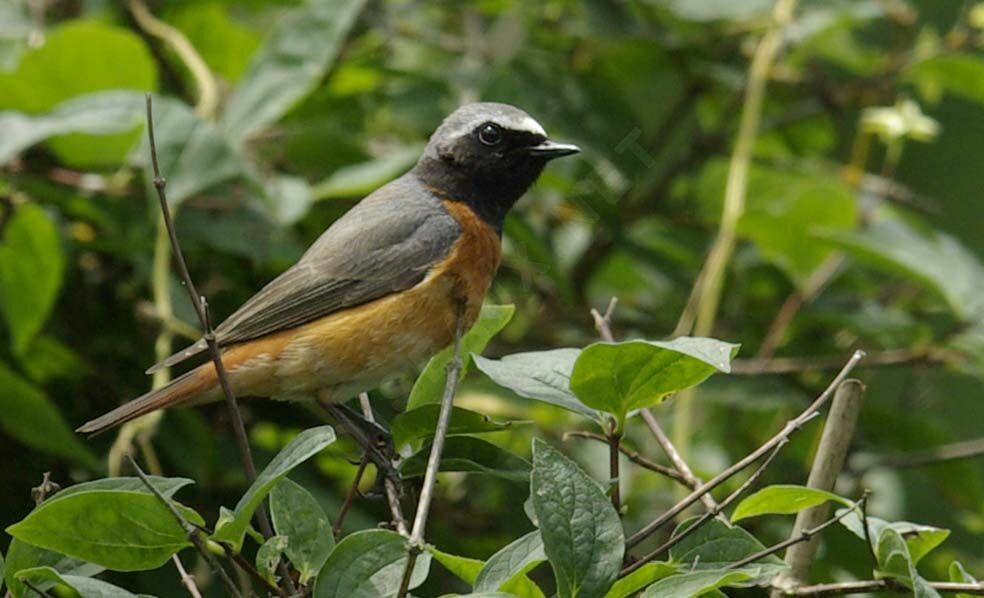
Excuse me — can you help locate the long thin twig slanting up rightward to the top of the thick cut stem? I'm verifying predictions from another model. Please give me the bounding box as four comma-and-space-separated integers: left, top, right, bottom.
626, 351, 864, 548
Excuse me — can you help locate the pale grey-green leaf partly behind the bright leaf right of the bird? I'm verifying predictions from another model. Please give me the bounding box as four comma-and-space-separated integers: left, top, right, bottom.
474, 349, 606, 423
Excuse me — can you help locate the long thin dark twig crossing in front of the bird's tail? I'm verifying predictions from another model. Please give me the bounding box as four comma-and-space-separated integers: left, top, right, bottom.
147, 93, 297, 594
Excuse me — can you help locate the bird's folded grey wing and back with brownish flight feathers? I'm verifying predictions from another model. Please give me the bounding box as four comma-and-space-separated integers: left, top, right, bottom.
148, 177, 461, 373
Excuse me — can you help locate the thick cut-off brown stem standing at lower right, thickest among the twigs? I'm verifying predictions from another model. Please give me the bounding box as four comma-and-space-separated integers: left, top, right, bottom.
772, 379, 864, 597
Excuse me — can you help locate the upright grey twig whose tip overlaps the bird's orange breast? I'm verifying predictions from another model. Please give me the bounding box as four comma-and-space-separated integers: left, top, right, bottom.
397, 310, 464, 598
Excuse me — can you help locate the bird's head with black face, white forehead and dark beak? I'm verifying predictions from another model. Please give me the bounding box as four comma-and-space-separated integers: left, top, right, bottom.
414, 102, 580, 227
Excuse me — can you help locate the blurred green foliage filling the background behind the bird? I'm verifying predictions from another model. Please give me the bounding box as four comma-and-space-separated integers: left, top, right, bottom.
0, 0, 984, 596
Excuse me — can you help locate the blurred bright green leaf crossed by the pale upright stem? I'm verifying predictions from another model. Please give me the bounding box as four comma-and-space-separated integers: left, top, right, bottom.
697, 160, 858, 288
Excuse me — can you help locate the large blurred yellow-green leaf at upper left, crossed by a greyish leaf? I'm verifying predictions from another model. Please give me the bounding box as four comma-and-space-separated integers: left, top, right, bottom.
0, 19, 157, 168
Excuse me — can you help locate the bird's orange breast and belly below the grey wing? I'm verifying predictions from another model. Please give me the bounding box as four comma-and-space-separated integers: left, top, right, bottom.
223, 201, 501, 400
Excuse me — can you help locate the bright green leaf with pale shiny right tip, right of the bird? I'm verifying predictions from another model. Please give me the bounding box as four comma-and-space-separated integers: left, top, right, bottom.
571, 337, 738, 424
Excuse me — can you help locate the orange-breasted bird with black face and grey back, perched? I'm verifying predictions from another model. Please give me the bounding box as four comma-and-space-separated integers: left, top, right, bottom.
77, 102, 580, 434
